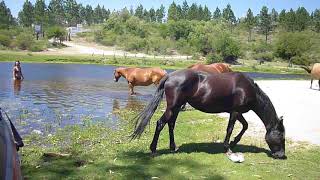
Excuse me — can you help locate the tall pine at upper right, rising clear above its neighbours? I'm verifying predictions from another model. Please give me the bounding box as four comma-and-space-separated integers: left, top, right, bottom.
259, 6, 272, 42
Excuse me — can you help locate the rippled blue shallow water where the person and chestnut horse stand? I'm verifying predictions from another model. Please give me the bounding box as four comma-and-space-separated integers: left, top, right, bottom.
0, 63, 303, 134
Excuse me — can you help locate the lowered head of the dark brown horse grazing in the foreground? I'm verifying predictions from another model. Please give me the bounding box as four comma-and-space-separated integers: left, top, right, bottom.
265, 116, 287, 159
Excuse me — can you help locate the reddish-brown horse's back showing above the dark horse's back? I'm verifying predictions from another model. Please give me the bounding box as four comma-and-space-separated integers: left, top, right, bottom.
188, 63, 232, 73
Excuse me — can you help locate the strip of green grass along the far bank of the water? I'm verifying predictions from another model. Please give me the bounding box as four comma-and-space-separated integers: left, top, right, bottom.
0, 51, 305, 74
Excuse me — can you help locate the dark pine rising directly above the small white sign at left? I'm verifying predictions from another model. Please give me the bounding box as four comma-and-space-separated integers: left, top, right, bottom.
34, 0, 49, 28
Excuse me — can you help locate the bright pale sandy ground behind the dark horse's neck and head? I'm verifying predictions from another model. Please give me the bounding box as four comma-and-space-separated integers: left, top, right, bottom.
220, 80, 320, 144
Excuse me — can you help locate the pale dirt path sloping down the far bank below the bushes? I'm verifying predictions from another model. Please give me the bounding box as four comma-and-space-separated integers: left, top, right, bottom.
38, 39, 191, 59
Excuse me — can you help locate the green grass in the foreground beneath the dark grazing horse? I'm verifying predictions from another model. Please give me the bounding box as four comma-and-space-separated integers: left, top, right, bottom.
22, 107, 320, 179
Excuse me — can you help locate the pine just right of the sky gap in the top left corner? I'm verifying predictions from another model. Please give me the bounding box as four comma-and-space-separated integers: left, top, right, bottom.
18, 0, 34, 27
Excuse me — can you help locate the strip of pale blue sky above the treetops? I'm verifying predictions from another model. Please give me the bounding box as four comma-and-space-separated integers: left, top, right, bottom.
0, 0, 320, 17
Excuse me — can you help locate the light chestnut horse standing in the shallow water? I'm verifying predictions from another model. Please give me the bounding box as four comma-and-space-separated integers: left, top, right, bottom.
114, 67, 167, 95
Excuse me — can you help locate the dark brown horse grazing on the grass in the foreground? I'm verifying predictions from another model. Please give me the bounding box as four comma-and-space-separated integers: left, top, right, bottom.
131, 69, 286, 159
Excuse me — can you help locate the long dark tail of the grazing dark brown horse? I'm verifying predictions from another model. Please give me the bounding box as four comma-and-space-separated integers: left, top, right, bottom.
130, 75, 169, 140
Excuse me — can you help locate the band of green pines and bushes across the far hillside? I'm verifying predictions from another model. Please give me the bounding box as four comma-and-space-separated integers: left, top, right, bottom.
0, 0, 320, 65
